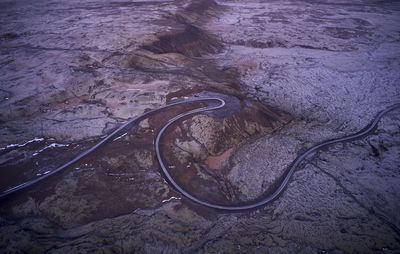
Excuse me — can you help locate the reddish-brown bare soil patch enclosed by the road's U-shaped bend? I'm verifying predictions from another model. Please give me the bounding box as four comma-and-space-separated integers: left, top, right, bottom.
161, 96, 291, 204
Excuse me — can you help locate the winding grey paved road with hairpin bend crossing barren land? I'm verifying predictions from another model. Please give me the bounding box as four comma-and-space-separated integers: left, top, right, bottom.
0, 97, 400, 211
